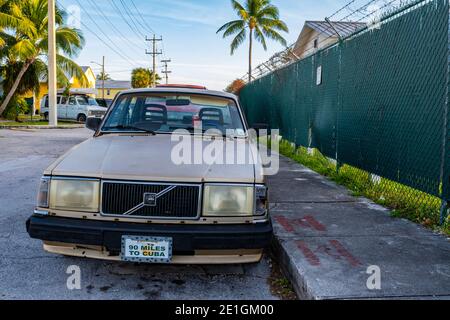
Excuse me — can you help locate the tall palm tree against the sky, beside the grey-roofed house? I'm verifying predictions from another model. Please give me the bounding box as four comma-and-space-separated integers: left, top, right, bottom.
217, 0, 289, 82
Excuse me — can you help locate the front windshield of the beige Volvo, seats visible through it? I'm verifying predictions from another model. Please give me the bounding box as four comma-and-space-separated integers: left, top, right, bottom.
102, 93, 245, 136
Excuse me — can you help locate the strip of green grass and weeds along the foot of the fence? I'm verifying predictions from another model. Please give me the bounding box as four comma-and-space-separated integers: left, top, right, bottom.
280, 140, 450, 236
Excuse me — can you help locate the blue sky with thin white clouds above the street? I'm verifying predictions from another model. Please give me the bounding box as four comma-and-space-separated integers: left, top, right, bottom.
58, 0, 348, 90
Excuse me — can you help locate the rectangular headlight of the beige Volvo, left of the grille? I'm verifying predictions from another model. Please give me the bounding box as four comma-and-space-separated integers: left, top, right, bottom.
50, 178, 100, 212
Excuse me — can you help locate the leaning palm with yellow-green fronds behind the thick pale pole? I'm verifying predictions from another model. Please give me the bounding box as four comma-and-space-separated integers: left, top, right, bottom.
0, 0, 87, 115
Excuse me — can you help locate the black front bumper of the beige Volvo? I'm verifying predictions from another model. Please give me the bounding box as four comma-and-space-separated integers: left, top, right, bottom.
26, 215, 272, 256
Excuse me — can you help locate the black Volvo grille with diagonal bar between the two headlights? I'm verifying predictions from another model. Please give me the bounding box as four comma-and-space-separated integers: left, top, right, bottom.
102, 181, 201, 219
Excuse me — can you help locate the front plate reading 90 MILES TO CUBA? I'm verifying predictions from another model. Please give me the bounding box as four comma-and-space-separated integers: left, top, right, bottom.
120, 236, 172, 263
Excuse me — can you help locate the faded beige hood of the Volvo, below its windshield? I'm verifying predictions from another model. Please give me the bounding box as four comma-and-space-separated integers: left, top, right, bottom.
45, 134, 263, 183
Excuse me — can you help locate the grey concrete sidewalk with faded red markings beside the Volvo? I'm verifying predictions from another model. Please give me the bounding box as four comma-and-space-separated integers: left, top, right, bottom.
267, 157, 450, 299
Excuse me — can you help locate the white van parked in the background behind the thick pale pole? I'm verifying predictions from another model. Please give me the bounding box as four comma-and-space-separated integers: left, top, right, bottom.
40, 94, 107, 122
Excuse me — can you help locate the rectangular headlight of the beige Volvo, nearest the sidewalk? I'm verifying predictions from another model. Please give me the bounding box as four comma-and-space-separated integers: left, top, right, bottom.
203, 185, 254, 216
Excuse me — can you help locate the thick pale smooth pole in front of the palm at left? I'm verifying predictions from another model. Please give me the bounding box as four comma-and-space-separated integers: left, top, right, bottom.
48, 0, 58, 126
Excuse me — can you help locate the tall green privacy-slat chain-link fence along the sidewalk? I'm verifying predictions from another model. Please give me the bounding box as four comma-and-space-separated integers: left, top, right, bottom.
240, 0, 450, 200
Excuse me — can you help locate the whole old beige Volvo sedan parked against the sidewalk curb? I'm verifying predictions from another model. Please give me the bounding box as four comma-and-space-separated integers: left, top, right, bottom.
27, 86, 272, 264
